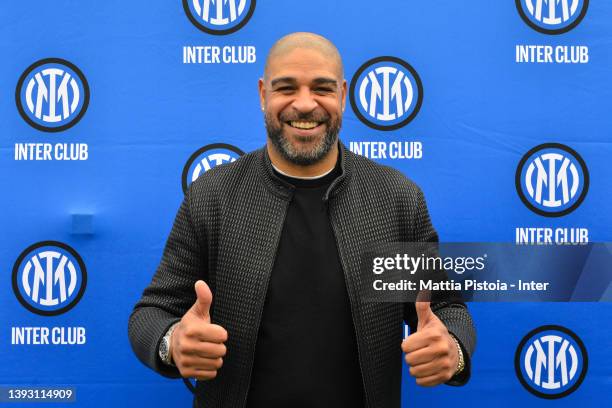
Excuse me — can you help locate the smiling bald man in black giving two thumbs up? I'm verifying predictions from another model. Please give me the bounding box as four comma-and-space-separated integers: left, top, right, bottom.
129, 33, 475, 408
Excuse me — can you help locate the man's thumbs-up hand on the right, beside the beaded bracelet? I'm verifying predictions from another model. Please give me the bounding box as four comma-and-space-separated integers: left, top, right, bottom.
402, 302, 459, 387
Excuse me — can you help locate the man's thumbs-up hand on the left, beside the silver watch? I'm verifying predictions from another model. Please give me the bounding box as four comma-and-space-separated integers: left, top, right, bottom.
170, 280, 227, 380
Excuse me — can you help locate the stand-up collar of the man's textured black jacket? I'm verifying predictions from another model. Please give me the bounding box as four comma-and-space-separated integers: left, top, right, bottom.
258, 140, 353, 201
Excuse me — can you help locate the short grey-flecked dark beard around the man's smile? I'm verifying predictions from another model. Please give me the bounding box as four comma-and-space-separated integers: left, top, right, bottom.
264, 112, 342, 166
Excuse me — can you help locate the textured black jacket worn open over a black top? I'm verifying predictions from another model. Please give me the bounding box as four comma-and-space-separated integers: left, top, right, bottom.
128, 143, 476, 408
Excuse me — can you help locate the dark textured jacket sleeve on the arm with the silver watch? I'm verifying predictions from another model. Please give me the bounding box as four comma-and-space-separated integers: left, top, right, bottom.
128, 189, 207, 378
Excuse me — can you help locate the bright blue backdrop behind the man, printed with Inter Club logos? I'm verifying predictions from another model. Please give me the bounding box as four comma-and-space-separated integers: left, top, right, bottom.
0, 0, 612, 407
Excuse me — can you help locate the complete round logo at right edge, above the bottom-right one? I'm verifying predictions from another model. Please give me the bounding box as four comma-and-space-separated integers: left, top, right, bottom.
515, 143, 589, 217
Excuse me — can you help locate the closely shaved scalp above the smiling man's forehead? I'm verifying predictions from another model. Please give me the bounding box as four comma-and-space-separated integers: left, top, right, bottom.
264, 32, 344, 82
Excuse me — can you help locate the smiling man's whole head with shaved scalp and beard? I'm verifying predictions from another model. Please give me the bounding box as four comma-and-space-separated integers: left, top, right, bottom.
258, 32, 346, 171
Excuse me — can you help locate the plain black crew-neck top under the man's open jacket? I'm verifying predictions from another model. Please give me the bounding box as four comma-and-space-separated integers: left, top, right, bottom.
247, 160, 364, 408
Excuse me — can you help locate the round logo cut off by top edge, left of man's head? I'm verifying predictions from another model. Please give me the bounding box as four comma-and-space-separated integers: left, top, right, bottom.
183, 0, 255, 35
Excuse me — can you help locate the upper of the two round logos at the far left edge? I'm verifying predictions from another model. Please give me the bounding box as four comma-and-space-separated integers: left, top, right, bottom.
15, 58, 89, 132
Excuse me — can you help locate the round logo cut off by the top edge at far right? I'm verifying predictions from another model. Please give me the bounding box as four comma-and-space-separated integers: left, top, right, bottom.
516, 0, 589, 34
